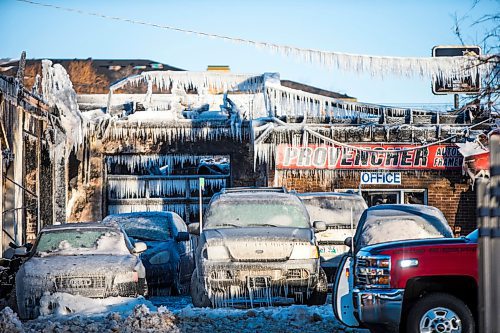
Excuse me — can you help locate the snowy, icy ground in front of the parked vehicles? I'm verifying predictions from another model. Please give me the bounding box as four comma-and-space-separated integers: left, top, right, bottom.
0, 294, 364, 333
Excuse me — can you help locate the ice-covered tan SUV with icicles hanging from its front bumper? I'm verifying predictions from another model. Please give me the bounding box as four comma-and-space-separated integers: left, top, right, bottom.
188, 188, 328, 307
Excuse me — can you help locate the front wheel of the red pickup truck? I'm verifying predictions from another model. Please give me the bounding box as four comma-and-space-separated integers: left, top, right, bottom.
406, 293, 475, 333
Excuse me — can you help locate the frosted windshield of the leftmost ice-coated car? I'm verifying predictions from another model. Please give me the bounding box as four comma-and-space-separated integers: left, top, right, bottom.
35, 229, 130, 257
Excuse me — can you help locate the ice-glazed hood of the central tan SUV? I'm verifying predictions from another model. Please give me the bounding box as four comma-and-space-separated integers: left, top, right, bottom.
203, 227, 313, 261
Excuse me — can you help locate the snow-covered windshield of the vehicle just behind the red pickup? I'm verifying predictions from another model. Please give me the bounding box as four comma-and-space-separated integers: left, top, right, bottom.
358, 206, 453, 248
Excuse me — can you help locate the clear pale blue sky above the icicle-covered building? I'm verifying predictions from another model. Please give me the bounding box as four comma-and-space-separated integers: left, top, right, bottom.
0, 0, 500, 104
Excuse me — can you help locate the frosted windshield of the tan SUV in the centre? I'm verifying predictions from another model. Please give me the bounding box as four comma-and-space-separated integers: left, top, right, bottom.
204, 196, 310, 229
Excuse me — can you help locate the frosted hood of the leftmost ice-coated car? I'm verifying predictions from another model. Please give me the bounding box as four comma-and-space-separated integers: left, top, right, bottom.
22, 255, 140, 278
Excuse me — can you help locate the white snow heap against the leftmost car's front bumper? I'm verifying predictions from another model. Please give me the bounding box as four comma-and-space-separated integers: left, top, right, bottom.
40, 293, 156, 316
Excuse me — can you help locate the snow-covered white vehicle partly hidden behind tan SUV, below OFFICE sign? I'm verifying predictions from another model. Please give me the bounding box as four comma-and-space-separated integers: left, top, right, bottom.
297, 192, 368, 278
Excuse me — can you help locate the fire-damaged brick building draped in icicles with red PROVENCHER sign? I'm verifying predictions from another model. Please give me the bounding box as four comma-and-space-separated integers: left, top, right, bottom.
0, 59, 494, 252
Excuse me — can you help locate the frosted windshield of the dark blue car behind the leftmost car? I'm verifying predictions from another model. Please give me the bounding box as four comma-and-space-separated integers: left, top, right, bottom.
103, 213, 172, 241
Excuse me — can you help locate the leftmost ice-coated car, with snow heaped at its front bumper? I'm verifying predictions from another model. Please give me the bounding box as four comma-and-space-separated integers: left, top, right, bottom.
13, 223, 147, 318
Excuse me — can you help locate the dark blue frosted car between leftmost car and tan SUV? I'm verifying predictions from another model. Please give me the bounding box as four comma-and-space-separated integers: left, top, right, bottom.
103, 211, 194, 295
